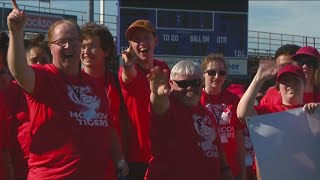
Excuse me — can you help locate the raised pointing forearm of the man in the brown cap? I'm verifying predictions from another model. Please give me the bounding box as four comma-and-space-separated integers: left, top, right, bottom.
121, 45, 137, 84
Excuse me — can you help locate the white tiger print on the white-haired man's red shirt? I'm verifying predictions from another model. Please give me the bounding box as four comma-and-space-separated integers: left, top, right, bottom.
192, 114, 219, 157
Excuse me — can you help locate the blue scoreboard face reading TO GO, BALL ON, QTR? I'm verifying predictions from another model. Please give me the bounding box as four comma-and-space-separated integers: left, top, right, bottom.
120, 7, 248, 58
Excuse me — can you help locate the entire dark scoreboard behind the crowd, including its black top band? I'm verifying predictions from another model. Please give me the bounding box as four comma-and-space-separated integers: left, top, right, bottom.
118, 0, 248, 75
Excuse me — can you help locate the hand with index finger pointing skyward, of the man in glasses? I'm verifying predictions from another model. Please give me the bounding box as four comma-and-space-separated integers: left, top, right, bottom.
7, 0, 27, 32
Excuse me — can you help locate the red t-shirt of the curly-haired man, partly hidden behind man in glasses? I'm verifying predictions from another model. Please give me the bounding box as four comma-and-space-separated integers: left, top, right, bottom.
97, 70, 121, 180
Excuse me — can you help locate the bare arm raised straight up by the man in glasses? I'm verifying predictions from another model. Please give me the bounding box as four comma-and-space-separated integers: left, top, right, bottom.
7, 0, 35, 93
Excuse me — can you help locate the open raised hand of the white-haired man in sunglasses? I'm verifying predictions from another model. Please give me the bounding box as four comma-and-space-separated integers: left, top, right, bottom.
147, 66, 170, 96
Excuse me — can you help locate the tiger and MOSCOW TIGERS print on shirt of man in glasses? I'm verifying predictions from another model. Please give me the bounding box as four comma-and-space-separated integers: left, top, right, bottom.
67, 85, 108, 126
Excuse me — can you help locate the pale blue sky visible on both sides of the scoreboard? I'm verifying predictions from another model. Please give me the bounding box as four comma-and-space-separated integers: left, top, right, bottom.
0, 0, 320, 37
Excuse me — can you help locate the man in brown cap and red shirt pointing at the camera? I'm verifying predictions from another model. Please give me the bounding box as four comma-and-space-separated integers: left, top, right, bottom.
118, 20, 169, 180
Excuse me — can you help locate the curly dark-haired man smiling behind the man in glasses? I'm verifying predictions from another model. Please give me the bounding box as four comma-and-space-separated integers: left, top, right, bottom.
81, 23, 126, 180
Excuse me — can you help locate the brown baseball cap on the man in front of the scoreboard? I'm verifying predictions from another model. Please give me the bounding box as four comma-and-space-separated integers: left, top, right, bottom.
125, 19, 156, 40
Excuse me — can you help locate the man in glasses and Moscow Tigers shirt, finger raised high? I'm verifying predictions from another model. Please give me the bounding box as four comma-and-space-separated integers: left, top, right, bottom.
8, 0, 127, 180
